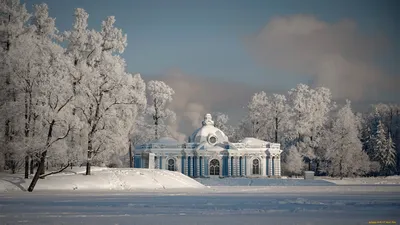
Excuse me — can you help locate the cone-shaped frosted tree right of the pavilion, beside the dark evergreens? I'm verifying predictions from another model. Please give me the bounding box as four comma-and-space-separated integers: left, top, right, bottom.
325, 101, 370, 178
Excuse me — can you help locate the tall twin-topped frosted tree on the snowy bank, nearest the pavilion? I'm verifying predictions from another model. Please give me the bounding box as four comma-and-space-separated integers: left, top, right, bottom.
66, 9, 145, 175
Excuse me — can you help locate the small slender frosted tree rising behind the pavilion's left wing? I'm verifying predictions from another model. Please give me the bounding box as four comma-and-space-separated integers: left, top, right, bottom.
147, 80, 176, 139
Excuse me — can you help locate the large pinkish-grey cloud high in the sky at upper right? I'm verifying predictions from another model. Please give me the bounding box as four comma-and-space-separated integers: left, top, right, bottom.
246, 15, 396, 100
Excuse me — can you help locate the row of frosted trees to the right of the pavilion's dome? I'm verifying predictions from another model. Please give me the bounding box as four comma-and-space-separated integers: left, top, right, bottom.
238, 84, 400, 177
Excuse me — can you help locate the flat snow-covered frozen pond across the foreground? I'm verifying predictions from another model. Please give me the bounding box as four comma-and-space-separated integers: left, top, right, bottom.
0, 193, 400, 225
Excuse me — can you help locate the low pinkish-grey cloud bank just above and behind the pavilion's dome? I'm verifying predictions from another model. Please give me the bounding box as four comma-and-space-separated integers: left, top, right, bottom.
143, 69, 270, 135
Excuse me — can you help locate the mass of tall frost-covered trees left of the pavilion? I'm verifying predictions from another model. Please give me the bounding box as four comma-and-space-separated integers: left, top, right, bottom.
0, 0, 175, 191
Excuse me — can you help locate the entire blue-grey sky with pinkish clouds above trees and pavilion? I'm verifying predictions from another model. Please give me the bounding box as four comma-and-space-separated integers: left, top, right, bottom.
23, 0, 400, 135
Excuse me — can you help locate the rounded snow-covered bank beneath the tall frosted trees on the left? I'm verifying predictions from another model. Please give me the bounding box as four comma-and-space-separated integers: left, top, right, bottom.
0, 167, 204, 192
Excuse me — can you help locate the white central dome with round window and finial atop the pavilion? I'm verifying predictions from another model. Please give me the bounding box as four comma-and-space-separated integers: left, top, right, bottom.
189, 114, 228, 145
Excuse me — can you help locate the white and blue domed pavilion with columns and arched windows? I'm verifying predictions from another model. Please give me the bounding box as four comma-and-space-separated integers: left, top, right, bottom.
134, 114, 282, 177
